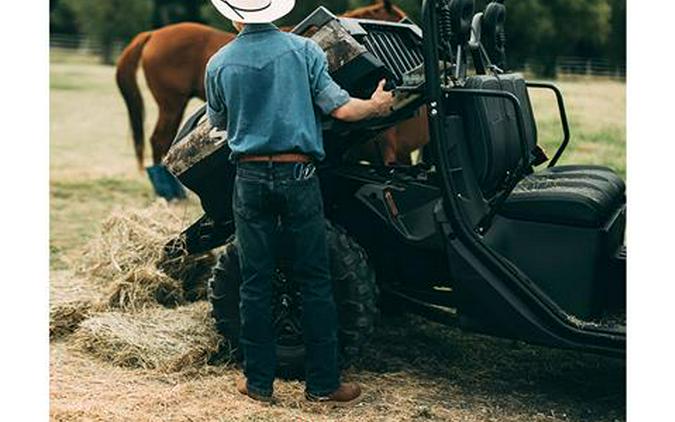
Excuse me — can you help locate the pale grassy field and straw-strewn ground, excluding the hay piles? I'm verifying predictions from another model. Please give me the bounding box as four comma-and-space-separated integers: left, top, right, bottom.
50, 51, 626, 422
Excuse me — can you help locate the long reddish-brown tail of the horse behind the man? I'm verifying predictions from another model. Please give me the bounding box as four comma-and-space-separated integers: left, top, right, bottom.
115, 31, 152, 170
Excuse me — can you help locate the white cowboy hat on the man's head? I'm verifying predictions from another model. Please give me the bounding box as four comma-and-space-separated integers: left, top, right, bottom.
211, 0, 295, 23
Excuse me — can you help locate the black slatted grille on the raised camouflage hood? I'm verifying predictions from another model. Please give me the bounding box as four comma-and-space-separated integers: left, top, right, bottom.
361, 23, 424, 83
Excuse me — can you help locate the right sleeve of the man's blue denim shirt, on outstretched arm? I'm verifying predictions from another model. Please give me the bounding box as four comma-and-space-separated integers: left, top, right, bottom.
307, 40, 350, 114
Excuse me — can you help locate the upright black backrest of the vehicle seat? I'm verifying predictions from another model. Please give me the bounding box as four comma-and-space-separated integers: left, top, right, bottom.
461, 74, 537, 199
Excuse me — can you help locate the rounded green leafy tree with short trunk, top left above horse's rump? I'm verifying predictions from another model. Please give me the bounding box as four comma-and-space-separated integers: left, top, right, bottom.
62, 0, 153, 64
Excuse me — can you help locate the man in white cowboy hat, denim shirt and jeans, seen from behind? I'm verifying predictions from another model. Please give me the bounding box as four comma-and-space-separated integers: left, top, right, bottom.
205, 0, 393, 402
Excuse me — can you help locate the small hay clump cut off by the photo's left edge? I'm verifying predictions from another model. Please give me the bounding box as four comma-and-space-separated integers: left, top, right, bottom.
49, 271, 103, 340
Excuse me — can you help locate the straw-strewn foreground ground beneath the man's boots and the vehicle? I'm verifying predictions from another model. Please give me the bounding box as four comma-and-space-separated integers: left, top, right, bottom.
51, 316, 625, 422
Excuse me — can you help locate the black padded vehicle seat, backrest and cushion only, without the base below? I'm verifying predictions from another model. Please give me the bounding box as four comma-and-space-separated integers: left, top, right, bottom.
463, 73, 626, 227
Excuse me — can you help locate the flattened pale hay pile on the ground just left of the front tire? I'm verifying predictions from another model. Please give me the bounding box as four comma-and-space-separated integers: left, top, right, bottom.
71, 302, 219, 372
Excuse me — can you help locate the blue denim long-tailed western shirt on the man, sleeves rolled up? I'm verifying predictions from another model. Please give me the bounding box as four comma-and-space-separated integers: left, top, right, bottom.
205, 24, 349, 160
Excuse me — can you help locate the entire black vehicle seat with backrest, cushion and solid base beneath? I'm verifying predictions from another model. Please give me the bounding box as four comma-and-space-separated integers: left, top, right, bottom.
460, 75, 626, 319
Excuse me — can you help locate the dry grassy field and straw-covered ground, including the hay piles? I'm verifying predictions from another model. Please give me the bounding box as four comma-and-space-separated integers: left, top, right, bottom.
50, 51, 626, 422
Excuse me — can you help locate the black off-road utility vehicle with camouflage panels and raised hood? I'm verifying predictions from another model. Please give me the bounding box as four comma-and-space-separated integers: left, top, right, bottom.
165, 0, 626, 376
